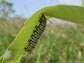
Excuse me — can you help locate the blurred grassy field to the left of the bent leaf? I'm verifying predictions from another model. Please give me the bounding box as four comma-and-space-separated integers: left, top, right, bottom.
0, 20, 23, 56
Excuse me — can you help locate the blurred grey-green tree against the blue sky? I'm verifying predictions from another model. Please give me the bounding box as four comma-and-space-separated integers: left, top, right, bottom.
0, 0, 15, 20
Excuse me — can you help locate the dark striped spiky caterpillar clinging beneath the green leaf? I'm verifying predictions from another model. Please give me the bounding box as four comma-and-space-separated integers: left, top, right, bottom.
25, 14, 46, 52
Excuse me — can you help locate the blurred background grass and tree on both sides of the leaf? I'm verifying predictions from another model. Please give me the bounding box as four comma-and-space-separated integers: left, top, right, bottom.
0, 0, 84, 63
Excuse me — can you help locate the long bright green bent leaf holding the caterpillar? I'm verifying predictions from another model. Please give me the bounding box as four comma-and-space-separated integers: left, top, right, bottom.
2, 5, 84, 63
